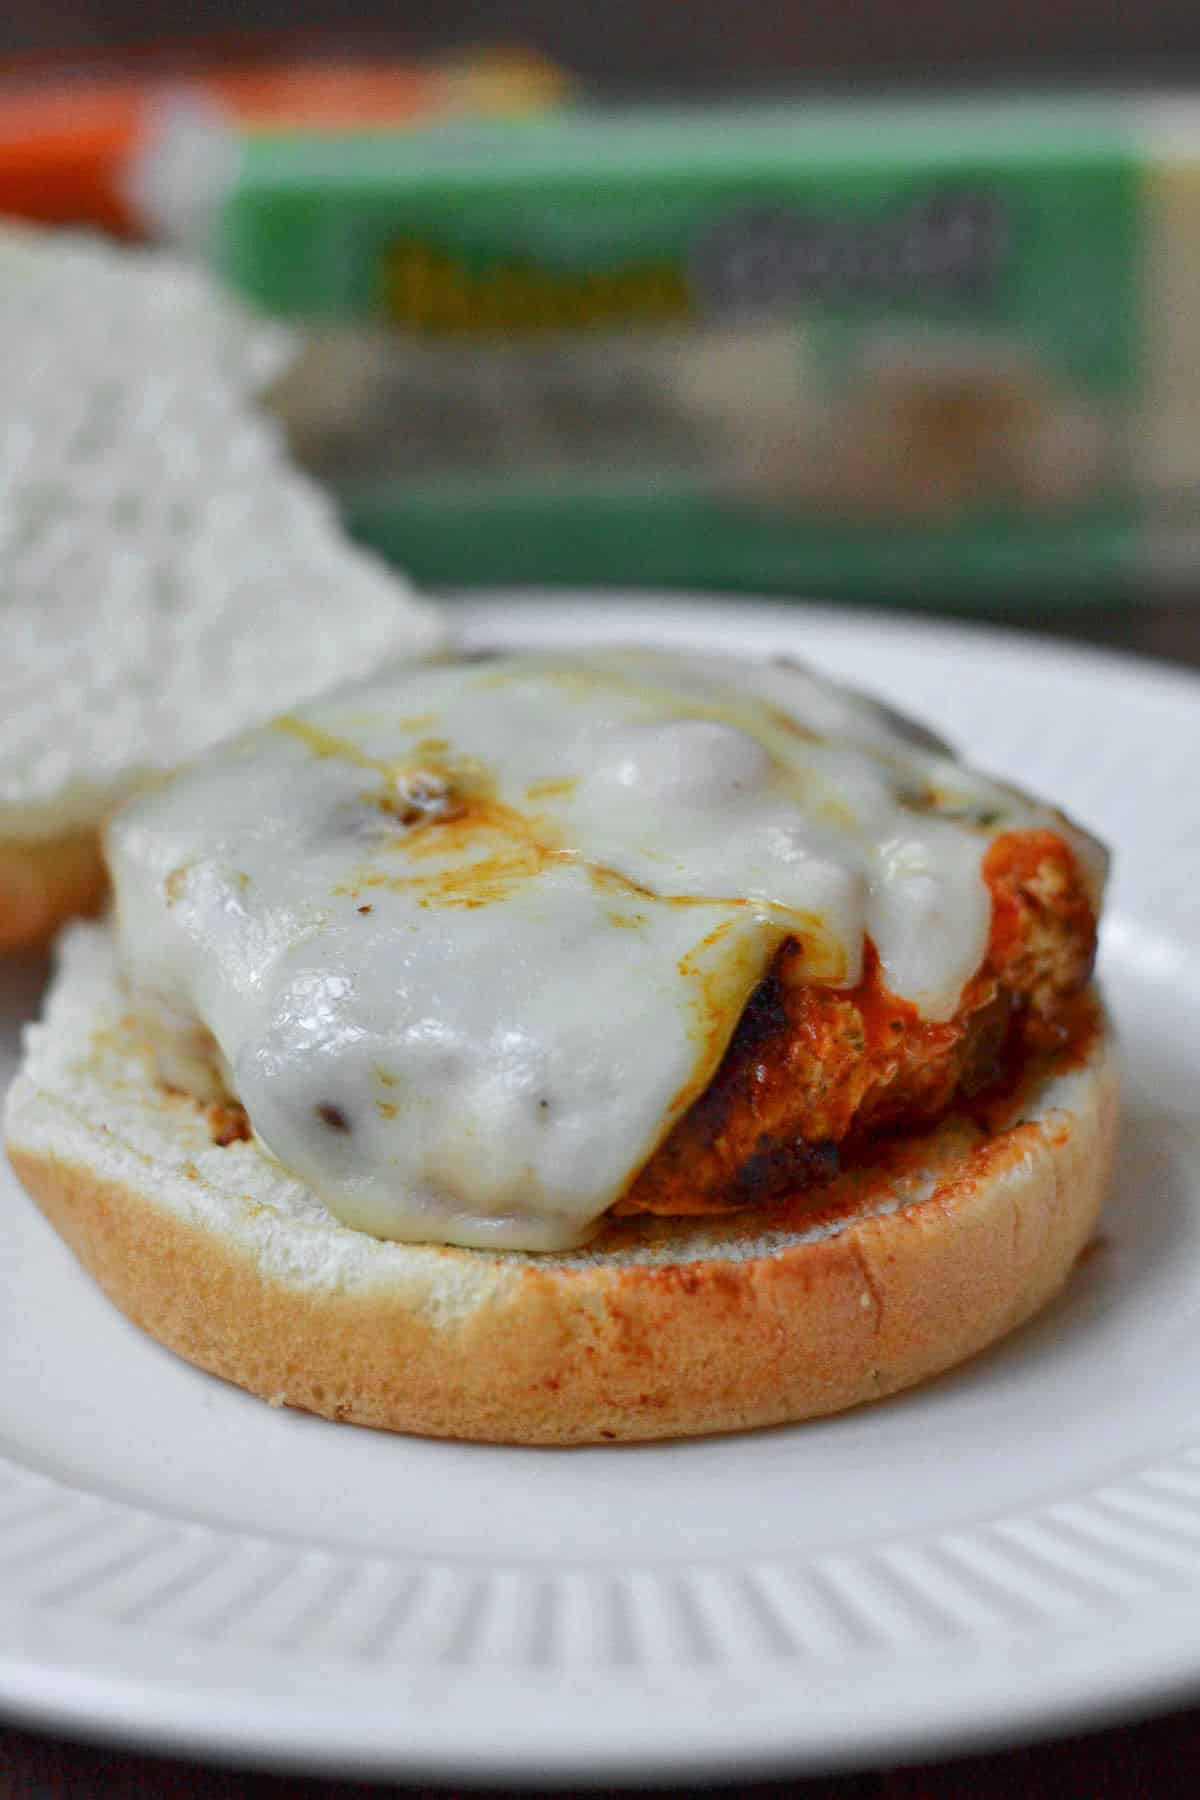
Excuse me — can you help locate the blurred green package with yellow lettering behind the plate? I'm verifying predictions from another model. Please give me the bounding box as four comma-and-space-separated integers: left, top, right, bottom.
216, 97, 1200, 603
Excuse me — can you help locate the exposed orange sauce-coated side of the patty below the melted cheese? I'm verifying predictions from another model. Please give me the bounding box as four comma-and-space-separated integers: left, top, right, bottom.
613, 830, 1096, 1215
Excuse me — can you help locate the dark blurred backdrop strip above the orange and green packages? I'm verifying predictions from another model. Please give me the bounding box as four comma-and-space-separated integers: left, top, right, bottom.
0, 0, 1200, 88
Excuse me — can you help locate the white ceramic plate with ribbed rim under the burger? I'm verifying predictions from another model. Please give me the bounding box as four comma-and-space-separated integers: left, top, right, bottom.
0, 596, 1200, 1782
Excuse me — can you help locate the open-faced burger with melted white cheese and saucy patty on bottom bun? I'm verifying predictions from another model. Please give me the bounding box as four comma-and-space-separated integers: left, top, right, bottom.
7, 650, 1115, 1444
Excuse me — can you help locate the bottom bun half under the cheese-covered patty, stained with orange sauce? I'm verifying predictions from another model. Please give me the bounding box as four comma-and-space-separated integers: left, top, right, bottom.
7, 925, 1115, 1444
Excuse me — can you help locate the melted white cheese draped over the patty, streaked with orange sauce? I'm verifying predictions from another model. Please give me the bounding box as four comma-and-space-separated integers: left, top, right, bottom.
108, 652, 1101, 1249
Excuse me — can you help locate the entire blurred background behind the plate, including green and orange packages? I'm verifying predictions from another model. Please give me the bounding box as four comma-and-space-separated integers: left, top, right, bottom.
0, 0, 1200, 657
